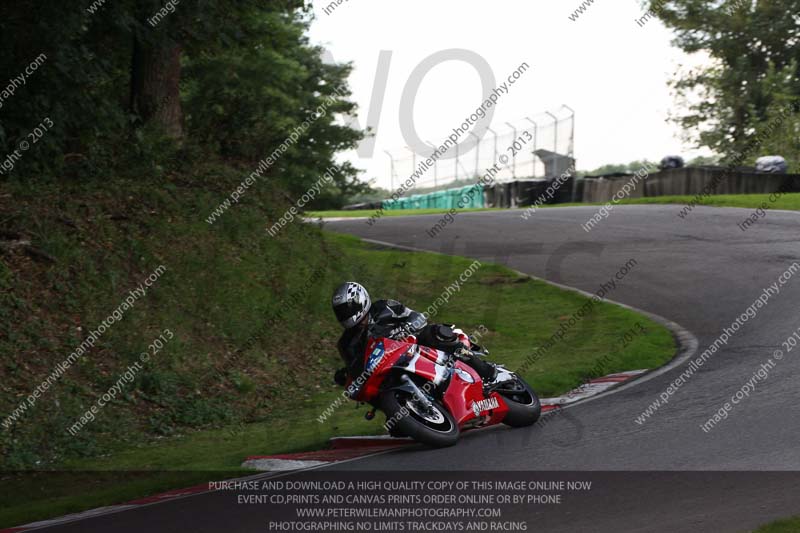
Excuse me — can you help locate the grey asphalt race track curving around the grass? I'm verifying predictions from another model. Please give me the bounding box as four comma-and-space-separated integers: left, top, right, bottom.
28, 206, 800, 532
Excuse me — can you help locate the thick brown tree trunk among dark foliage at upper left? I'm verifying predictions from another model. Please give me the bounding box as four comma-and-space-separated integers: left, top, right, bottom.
131, 39, 183, 140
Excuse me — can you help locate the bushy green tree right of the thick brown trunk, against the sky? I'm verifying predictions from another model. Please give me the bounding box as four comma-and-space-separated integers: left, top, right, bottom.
185, 3, 365, 202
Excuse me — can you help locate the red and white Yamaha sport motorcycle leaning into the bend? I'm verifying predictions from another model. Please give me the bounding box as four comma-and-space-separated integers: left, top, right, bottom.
350, 332, 541, 448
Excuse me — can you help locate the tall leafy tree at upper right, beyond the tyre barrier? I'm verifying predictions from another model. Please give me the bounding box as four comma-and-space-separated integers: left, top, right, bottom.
649, 0, 800, 159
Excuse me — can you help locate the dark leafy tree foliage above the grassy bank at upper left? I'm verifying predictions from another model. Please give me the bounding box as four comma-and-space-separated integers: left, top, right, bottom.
0, 0, 363, 207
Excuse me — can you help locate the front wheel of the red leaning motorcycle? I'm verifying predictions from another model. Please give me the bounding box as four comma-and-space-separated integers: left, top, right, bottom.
380, 389, 459, 448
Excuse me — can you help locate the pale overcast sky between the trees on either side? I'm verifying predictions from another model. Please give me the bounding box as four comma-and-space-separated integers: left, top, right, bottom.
311, 0, 706, 187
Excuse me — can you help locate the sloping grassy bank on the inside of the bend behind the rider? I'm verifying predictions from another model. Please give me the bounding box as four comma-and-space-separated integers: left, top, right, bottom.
0, 169, 674, 527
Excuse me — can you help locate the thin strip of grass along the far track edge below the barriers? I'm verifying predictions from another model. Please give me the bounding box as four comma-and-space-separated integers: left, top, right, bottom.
308, 193, 800, 218
